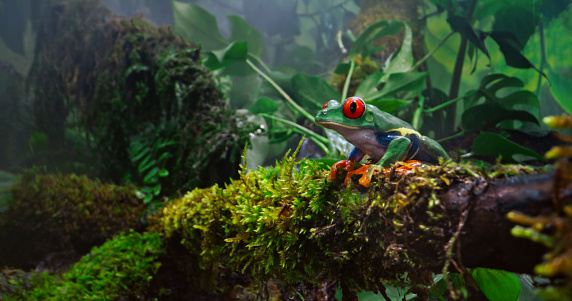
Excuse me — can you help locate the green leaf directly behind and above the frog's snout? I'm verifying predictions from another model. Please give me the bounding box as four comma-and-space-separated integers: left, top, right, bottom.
292, 73, 342, 111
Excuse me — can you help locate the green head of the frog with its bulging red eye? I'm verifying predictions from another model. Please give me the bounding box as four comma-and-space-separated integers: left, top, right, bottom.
316, 97, 375, 133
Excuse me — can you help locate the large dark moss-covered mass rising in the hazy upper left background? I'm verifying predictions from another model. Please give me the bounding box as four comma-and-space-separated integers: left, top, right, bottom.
29, 1, 254, 191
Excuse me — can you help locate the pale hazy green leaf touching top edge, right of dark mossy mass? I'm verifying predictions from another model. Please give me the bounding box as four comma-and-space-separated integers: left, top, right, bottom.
172, 1, 228, 51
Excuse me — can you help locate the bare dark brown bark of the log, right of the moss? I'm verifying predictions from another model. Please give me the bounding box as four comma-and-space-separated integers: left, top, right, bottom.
440, 172, 572, 273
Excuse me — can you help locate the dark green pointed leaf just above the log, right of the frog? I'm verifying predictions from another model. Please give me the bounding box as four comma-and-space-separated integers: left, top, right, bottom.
469, 132, 546, 162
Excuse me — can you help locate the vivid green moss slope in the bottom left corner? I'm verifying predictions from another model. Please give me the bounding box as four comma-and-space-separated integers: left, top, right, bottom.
0, 231, 164, 301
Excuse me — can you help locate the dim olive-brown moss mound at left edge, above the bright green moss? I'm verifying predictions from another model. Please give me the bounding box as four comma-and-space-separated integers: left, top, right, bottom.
0, 171, 143, 268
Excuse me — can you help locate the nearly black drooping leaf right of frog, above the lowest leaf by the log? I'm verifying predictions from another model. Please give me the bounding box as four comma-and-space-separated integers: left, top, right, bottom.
461, 103, 539, 130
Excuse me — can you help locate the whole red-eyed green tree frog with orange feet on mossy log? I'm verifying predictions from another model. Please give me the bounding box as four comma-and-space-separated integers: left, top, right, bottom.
316, 97, 449, 186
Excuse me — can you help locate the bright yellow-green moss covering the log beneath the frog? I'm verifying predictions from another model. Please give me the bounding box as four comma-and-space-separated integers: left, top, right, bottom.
151, 141, 524, 291
